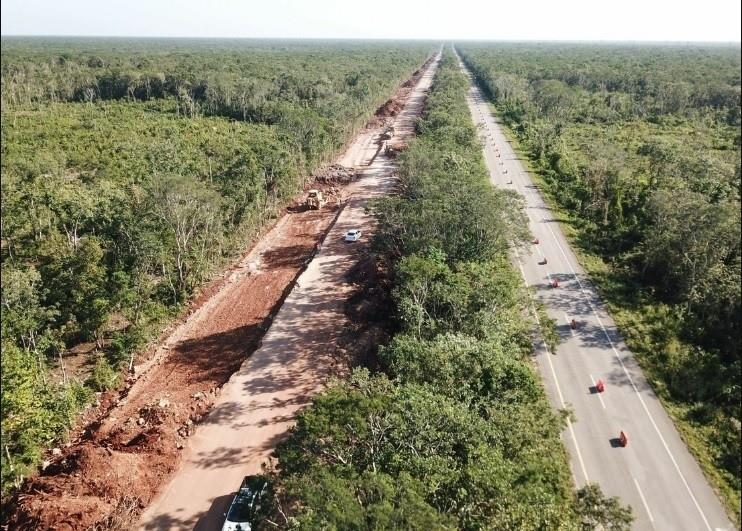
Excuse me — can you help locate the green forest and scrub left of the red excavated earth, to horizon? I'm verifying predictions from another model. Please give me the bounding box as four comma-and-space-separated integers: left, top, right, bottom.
0, 40, 432, 493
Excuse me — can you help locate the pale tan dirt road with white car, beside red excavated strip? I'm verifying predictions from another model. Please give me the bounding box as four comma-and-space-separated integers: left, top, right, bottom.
140, 55, 437, 530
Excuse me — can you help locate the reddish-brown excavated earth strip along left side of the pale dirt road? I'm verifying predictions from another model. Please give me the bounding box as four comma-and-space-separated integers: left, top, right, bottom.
3, 56, 436, 530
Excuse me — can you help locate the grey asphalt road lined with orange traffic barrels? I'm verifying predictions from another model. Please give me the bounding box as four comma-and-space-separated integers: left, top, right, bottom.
462, 50, 734, 531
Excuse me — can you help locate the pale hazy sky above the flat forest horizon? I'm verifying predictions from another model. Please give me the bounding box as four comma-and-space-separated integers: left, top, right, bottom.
0, 0, 742, 42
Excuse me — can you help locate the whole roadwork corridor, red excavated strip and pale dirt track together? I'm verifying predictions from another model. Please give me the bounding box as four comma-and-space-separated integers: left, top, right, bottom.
2, 51, 434, 531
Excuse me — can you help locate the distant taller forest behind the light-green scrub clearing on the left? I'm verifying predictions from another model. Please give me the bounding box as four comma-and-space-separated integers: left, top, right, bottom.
0, 37, 430, 165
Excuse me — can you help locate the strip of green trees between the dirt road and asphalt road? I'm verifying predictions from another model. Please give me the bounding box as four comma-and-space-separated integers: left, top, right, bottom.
261, 53, 631, 530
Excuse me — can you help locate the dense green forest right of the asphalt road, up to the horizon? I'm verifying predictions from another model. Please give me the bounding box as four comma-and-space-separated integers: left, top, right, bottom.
459, 43, 742, 522
